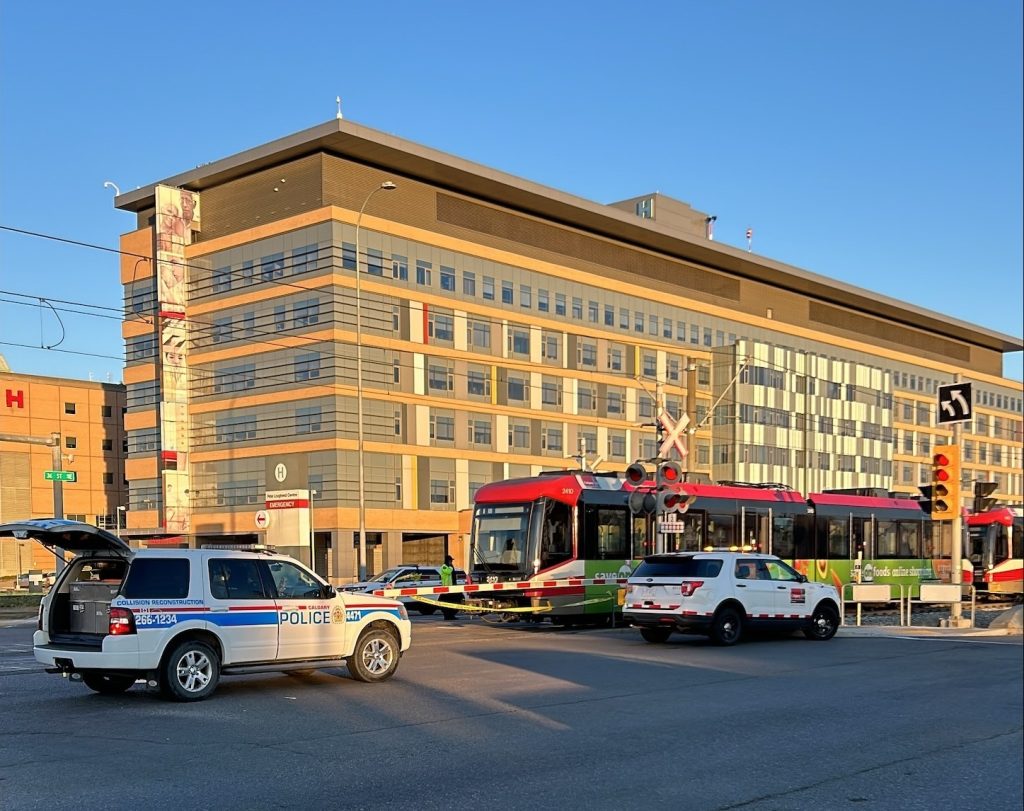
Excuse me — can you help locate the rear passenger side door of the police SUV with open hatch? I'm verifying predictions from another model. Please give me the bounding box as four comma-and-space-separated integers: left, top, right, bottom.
207, 556, 278, 664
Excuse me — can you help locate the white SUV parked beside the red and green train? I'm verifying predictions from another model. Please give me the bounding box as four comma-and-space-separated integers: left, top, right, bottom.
623, 551, 840, 645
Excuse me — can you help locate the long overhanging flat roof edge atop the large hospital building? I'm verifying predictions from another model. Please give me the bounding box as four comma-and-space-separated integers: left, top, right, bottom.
115, 119, 1024, 352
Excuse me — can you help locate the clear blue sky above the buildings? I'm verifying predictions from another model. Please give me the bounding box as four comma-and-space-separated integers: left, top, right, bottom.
0, 0, 1024, 381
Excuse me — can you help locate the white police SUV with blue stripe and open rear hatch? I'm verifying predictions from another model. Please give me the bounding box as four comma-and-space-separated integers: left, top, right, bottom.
0, 519, 412, 701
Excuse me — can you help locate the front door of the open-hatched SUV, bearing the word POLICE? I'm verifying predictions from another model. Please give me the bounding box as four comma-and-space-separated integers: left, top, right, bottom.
266, 560, 345, 659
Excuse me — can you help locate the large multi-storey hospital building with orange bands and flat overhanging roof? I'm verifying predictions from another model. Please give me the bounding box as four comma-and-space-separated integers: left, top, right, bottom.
117, 120, 1022, 580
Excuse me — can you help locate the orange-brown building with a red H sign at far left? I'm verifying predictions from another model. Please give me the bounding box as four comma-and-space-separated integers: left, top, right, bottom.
0, 357, 128, 579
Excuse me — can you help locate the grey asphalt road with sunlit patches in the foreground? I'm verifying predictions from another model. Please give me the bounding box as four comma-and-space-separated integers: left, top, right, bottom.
0, 616, 1024, 811
